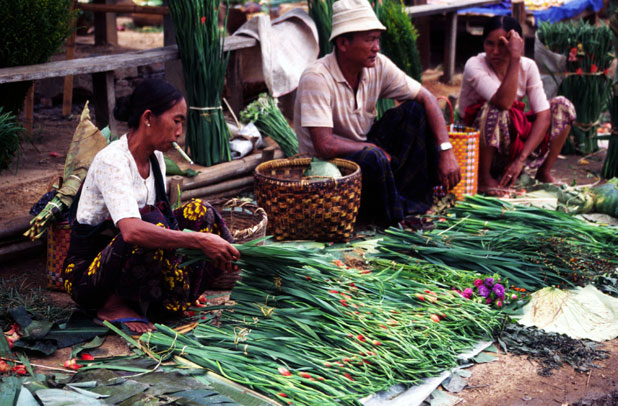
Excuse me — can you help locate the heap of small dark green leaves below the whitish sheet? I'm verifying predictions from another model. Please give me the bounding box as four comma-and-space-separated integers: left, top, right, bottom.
496, 324, 609, 376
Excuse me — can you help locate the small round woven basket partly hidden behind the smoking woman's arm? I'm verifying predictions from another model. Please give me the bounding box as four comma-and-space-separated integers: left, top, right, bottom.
210, 199, 268, 244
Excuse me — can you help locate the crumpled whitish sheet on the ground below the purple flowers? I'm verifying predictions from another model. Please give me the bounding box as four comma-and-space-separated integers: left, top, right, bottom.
518, 285, 618, 341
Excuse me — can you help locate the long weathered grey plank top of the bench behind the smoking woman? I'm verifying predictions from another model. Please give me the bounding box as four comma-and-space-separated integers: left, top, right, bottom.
0, 36, 257, 83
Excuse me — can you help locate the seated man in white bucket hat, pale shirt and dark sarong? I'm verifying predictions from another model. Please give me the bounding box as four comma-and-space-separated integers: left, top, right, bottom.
294, 0, 461, 223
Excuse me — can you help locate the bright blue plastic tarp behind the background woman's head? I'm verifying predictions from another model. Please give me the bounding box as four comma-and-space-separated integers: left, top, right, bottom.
459, 0, 603, 25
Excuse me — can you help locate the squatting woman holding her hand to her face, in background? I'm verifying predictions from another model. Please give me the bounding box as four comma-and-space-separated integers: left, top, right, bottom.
459, 16, 575, 195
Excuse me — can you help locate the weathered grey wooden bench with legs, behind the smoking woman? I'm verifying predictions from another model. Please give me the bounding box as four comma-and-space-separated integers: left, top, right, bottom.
0, 37, 257, 132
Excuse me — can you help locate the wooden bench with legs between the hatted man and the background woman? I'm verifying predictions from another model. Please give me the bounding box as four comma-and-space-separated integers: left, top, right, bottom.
406, 0, 501, 83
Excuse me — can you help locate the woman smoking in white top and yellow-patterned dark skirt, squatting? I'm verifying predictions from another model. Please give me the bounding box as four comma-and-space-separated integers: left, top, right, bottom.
63, 79, 240, 333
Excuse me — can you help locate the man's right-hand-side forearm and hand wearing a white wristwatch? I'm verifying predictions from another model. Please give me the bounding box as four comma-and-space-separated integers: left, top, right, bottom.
416, 87, 461, 190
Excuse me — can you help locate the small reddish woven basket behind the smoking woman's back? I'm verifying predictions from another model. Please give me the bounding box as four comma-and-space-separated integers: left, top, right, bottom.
47, 221, 71, 290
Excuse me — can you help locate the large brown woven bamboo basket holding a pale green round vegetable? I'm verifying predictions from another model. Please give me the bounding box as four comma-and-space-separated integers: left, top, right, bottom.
254, 158, 362, 241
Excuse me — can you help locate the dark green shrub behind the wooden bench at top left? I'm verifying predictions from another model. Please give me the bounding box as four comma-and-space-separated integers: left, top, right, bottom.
0, 0, 74, 113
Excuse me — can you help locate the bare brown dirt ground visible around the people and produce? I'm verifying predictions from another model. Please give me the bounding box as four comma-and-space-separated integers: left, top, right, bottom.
0, 16, 618, 406
